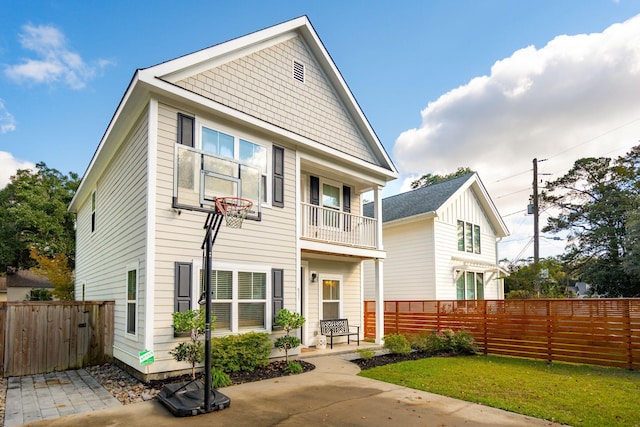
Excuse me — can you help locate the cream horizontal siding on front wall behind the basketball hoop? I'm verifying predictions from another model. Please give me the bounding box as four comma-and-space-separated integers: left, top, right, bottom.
154, 102, 297, 363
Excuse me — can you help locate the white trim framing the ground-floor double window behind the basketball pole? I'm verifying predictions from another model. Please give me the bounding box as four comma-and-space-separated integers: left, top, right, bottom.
191, 259, 273, 336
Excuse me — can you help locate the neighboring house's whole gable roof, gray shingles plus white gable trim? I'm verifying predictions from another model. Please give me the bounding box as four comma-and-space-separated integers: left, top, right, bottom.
363, 172, 509, 237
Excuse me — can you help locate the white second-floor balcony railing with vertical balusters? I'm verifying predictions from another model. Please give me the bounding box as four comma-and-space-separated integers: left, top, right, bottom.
301, 203, 376, 249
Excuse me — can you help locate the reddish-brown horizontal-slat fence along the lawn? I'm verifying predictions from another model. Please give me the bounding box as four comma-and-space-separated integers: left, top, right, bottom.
364, 299, 640, 369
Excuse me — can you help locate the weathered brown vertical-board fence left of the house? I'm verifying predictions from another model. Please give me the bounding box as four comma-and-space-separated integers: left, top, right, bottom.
0, 301, 114, 377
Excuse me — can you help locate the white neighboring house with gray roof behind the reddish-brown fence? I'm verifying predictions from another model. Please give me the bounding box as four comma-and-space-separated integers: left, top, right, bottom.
364, 173, 508, 300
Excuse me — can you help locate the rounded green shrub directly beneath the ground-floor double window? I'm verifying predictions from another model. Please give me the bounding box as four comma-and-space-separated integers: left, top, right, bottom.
211, 332, 271, 373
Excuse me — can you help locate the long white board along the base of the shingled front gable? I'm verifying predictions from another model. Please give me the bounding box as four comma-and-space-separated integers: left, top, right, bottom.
139, 70, 398, 181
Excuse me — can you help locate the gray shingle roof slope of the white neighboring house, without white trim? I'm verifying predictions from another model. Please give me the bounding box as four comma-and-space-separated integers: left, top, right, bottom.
362, 173, 474, 222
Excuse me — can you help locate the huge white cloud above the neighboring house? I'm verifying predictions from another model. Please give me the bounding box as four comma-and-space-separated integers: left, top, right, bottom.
394, 15, 640, 260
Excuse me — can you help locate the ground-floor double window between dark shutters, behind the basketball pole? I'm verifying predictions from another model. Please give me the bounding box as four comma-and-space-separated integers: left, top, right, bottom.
197, 265, 270, 334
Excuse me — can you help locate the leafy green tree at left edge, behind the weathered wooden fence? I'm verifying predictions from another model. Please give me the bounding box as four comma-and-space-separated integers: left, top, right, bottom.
0, 163, 80, 271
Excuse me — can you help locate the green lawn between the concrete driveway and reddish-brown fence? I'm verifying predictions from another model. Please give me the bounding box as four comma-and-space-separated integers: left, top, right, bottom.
360, 356, 640, 427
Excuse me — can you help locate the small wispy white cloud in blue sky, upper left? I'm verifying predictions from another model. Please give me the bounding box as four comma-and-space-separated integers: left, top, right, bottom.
5, 24, 110, 89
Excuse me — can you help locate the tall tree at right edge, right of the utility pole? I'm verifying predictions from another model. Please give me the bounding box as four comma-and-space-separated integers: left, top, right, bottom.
541, 147, 640, 297
